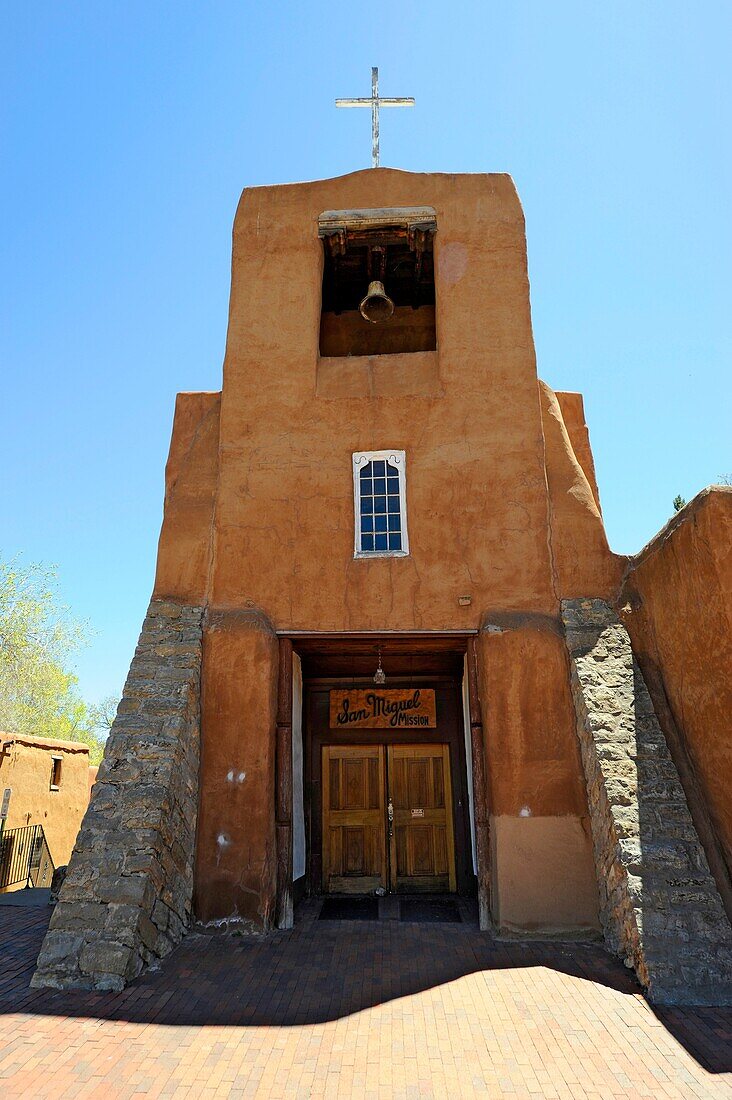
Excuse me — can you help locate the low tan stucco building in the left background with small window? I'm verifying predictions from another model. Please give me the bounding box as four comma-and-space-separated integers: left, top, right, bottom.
0, 734, 89, 880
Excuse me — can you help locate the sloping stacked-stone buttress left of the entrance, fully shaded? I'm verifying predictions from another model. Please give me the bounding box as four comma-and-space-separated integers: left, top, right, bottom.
31, 600, 203, 990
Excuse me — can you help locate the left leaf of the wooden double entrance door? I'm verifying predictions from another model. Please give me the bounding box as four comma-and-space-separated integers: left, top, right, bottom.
323, 745, 386, 893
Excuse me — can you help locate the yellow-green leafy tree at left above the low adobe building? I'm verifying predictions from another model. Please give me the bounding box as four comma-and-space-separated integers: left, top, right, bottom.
0, 561, 109, 763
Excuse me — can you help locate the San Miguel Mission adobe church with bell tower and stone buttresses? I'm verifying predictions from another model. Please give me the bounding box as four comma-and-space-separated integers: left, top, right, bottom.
34, 168, 732, 1002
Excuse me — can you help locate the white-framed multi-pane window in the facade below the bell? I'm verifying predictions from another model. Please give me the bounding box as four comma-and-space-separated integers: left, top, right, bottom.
353, 451, 409, 558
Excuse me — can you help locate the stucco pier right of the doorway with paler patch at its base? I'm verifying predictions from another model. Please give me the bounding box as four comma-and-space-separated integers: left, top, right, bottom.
479, 613, 599, 931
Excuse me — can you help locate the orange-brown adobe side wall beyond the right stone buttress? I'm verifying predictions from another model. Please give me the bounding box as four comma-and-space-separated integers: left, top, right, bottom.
620, 486, 732, 871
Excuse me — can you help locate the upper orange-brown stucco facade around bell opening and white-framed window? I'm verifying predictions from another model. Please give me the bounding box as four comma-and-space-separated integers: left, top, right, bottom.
155, 169, 619, 630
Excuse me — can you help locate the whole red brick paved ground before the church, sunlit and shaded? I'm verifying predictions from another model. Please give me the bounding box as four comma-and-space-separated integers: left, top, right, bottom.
0, 909, 732, 1100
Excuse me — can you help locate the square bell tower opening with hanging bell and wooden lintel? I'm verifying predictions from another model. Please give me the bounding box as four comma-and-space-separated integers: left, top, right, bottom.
318, 207, 437, 356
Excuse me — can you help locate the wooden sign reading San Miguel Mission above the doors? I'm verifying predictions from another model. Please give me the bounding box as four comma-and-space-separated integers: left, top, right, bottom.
330, 688, 437, 729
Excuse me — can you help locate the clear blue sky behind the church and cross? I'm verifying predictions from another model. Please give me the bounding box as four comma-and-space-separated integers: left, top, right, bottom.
0, 0, 732, 701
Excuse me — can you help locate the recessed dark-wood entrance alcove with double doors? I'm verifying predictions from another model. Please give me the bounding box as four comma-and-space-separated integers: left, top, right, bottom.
277, 635, 477, 903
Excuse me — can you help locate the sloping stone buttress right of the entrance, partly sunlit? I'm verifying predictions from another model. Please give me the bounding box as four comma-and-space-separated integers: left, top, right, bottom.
562, 600, 732, 1004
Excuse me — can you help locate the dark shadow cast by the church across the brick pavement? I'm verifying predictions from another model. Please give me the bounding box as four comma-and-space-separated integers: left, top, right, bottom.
0, 908, 732, 1074
